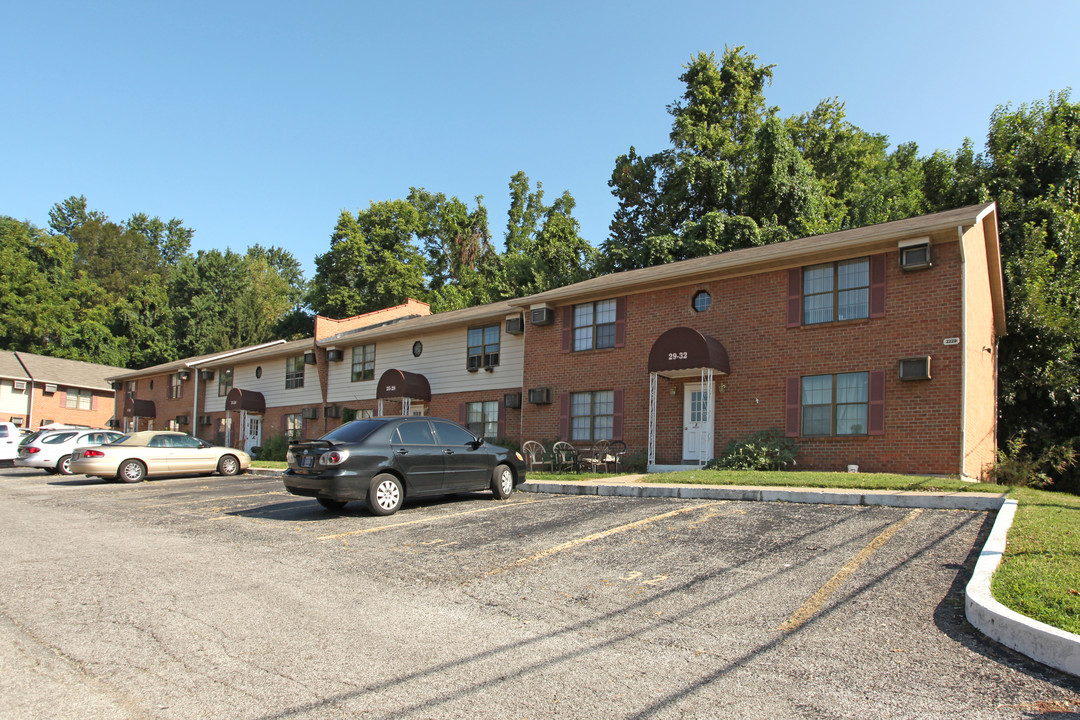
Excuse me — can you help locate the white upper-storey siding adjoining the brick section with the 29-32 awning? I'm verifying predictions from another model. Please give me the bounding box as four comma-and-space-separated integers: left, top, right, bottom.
324, 321, 525, 405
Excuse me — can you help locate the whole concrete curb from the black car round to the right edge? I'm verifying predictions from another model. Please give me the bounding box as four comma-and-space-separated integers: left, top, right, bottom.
518, 480, 1080, 676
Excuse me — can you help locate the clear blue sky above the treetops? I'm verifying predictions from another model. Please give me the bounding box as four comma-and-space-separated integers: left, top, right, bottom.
0, 0, 1080, 276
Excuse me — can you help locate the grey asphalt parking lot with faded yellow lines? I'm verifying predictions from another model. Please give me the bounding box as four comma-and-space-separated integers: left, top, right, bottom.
0, 468, 1080, 719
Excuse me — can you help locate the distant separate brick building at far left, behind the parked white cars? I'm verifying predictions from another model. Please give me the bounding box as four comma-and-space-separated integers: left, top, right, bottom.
0, 351, 125, 427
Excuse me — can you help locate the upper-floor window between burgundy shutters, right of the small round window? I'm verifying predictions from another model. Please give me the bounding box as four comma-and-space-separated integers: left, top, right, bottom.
802, 258, 870, 325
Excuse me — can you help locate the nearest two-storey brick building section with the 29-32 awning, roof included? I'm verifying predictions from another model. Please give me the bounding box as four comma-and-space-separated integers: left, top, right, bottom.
511, 203, 1005, 476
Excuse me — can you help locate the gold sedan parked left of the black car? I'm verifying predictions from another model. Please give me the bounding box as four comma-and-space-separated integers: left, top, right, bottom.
71, 431, 252, 483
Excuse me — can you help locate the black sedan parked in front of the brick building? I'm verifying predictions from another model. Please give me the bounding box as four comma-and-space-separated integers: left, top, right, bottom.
284, 417, 525, 515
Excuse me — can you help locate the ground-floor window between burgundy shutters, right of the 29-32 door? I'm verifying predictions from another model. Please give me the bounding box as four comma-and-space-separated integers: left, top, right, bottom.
801, 372, 869, 437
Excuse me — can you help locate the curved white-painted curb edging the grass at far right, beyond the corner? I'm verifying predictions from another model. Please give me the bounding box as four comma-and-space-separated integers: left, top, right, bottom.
964, 500, 1080, 676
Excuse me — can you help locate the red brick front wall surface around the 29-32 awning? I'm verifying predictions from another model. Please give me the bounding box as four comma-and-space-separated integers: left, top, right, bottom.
523, 235, 976, 474
